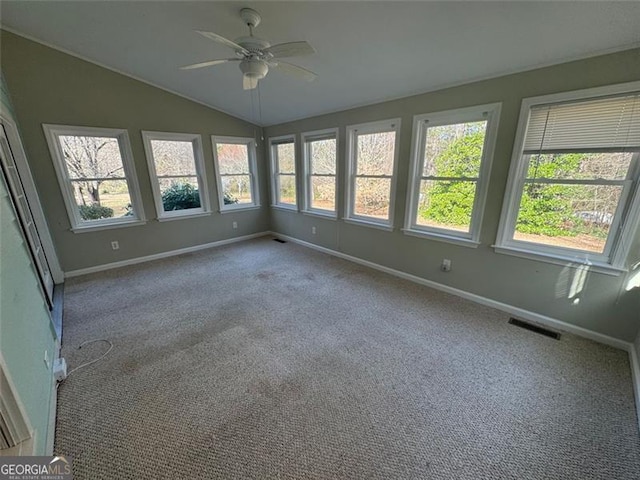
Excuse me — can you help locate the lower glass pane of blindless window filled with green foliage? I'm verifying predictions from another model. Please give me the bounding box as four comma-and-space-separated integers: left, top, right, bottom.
416, 180, 477, 232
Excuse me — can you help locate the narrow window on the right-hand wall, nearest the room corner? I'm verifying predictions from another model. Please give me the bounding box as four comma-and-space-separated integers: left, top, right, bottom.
269, 135, 298, 209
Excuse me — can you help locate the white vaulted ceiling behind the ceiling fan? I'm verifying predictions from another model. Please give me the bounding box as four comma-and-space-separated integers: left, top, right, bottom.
0, 0, 640, 125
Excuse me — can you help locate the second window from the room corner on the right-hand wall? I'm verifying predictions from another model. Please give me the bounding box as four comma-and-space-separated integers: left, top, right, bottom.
302, 129, 338, 216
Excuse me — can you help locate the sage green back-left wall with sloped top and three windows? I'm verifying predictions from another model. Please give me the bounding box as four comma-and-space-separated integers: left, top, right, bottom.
0, 31, 269, 271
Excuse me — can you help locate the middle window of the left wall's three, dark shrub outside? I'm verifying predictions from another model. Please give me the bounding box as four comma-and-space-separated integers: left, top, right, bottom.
142, 132, 210, 221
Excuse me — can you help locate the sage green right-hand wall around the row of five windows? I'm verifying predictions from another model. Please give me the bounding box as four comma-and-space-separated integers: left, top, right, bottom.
265, 49, 640, 341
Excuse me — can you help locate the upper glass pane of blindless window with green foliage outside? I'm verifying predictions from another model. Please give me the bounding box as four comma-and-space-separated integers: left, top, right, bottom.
422, 121, 487, 178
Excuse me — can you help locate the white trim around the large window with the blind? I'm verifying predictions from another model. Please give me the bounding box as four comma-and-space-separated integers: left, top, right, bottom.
493, 81, 640, 275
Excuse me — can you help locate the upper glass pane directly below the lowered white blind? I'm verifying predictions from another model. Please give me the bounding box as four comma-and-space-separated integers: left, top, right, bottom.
527, 152, 633, 180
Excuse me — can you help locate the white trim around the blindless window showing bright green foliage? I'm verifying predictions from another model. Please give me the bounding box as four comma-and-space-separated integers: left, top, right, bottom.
403, 103, 502, 244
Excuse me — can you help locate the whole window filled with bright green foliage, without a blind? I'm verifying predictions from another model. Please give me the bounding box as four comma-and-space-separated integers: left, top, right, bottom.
405, 104, 500, 245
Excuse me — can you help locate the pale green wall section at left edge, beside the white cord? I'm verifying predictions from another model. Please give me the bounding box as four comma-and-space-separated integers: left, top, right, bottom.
0, 168, 56, 455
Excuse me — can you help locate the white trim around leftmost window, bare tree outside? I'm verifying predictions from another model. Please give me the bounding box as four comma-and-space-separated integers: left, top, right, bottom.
42, 124, 146, 233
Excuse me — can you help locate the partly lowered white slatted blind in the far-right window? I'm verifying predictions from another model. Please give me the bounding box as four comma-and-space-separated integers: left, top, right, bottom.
524, 93, 640, 154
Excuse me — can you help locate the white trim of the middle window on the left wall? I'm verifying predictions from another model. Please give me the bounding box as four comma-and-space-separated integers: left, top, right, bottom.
141, 130, 211, 222
